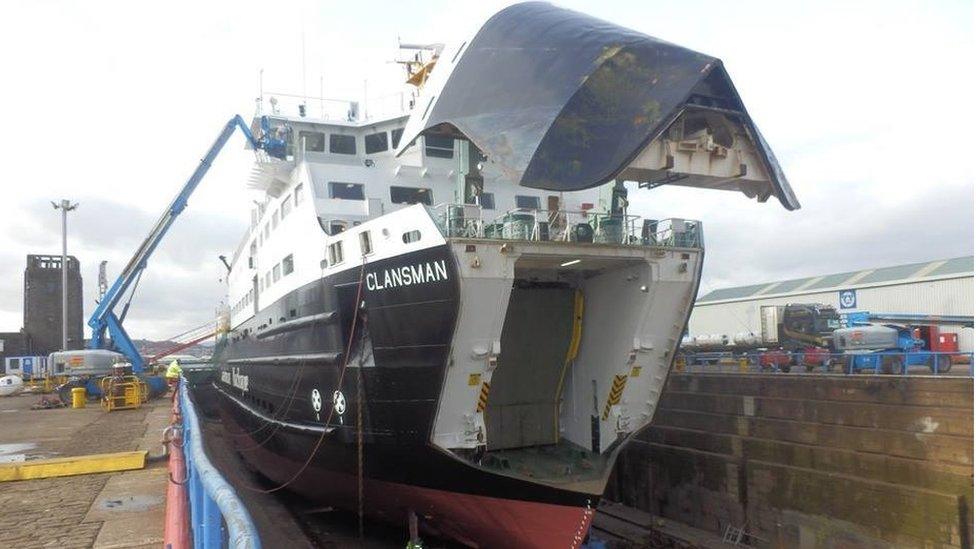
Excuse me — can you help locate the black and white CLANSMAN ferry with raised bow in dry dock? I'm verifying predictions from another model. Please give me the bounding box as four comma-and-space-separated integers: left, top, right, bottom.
214, 3, 799, 547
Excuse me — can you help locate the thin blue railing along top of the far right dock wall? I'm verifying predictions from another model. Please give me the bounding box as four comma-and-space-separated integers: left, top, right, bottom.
675, 349, 973, 377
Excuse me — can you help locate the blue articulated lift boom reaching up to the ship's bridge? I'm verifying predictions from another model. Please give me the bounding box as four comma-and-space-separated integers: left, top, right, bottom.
88, 115, 286, 374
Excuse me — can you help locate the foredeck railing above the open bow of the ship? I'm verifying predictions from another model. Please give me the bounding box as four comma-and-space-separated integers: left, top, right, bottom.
430, 204, 703, 248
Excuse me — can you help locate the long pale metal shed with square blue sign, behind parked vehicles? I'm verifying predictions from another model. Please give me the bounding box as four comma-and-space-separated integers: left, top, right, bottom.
688, 256, 973, 352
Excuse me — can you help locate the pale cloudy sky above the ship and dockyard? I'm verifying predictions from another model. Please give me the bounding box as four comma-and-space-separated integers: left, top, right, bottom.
0, 0, 976, 339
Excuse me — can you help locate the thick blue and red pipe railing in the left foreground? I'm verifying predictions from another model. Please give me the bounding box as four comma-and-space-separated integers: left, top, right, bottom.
166, 378, 261, 549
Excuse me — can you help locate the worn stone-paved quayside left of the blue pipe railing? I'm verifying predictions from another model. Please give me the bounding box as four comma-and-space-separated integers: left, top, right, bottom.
0, 394, 171, 548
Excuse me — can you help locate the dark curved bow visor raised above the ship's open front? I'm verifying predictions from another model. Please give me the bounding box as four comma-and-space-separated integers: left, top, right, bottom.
397, 2, 800, 210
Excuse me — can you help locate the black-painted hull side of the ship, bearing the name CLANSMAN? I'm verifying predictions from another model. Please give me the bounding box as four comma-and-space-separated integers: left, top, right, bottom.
215, 245, 600, 546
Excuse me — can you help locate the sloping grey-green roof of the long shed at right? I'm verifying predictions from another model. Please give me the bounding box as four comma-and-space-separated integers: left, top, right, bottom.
696, 255, 973, 303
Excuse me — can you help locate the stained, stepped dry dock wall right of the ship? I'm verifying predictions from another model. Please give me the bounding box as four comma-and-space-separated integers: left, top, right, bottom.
607, 373, 973, 548
